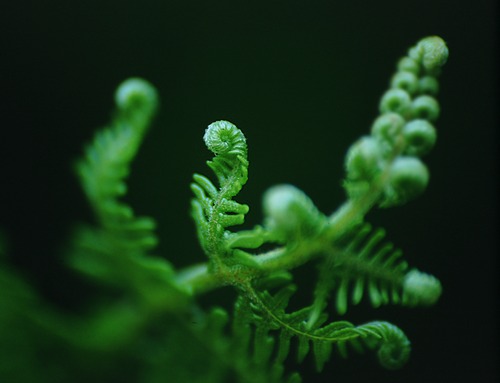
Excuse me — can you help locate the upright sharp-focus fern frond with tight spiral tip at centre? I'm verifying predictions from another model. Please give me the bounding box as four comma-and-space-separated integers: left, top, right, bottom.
191, 121, 265, 263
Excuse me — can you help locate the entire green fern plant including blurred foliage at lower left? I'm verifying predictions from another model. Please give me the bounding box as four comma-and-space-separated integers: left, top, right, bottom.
0, 37, 448, 383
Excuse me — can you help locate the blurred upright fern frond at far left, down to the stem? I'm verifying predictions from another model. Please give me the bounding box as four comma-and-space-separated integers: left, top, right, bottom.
69, 78, 190, 308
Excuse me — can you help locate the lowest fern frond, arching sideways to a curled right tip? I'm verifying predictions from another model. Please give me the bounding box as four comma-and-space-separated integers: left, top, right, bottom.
240, 285, 410, 371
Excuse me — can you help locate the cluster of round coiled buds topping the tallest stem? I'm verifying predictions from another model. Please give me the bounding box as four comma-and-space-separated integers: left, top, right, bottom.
344, 36, 448, 207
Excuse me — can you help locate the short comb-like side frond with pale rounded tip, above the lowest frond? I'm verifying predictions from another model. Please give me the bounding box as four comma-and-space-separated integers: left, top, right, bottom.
310, 224, 441, 316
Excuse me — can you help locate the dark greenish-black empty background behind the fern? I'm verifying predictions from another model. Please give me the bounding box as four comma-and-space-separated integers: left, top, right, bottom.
0, 0, 500, 382
